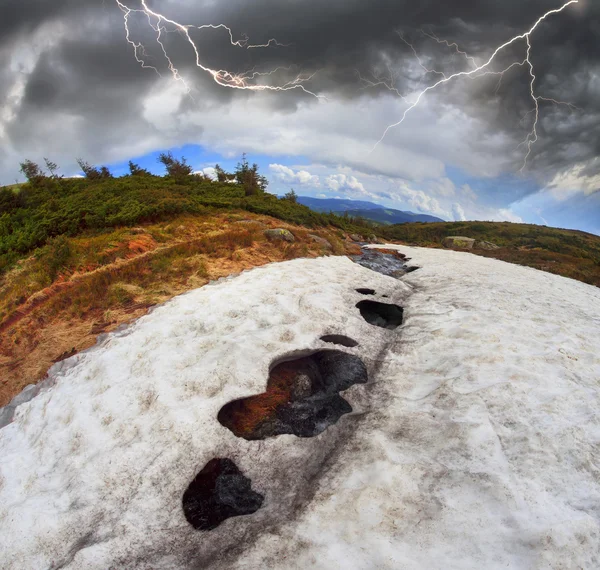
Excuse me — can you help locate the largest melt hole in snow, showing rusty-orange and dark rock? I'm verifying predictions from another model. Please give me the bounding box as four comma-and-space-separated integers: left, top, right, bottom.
217, 350, 368, 440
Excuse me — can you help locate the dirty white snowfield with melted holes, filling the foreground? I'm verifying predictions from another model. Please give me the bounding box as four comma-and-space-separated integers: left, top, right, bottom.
0, 250, 600, 570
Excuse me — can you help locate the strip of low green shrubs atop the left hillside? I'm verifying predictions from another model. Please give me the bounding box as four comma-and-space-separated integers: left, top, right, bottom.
0, 176, 373, 273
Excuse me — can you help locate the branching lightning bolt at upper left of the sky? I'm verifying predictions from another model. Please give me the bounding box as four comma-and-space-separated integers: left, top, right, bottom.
115, 0, 325, 99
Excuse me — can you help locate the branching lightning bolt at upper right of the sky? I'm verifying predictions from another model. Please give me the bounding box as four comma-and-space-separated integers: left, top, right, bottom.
371, 0, 580, 172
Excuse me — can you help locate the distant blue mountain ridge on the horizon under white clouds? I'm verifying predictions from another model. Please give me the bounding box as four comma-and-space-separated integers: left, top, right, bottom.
298, 196, 445, 225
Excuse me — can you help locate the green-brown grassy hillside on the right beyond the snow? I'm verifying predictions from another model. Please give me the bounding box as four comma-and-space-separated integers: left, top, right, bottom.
381, 222, 600, 287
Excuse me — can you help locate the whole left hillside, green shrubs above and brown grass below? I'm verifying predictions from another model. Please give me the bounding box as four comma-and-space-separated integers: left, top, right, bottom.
0, 175, 376, 406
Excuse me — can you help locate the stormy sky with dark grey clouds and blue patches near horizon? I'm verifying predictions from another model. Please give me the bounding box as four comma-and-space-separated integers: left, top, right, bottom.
0, 0, 600, 234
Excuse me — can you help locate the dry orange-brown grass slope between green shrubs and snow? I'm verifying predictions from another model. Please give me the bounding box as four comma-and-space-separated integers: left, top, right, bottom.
0, 211, 350, 406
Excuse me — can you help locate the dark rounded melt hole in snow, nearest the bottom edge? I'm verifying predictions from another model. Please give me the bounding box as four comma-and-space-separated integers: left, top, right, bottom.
183, 459, 264, 530
